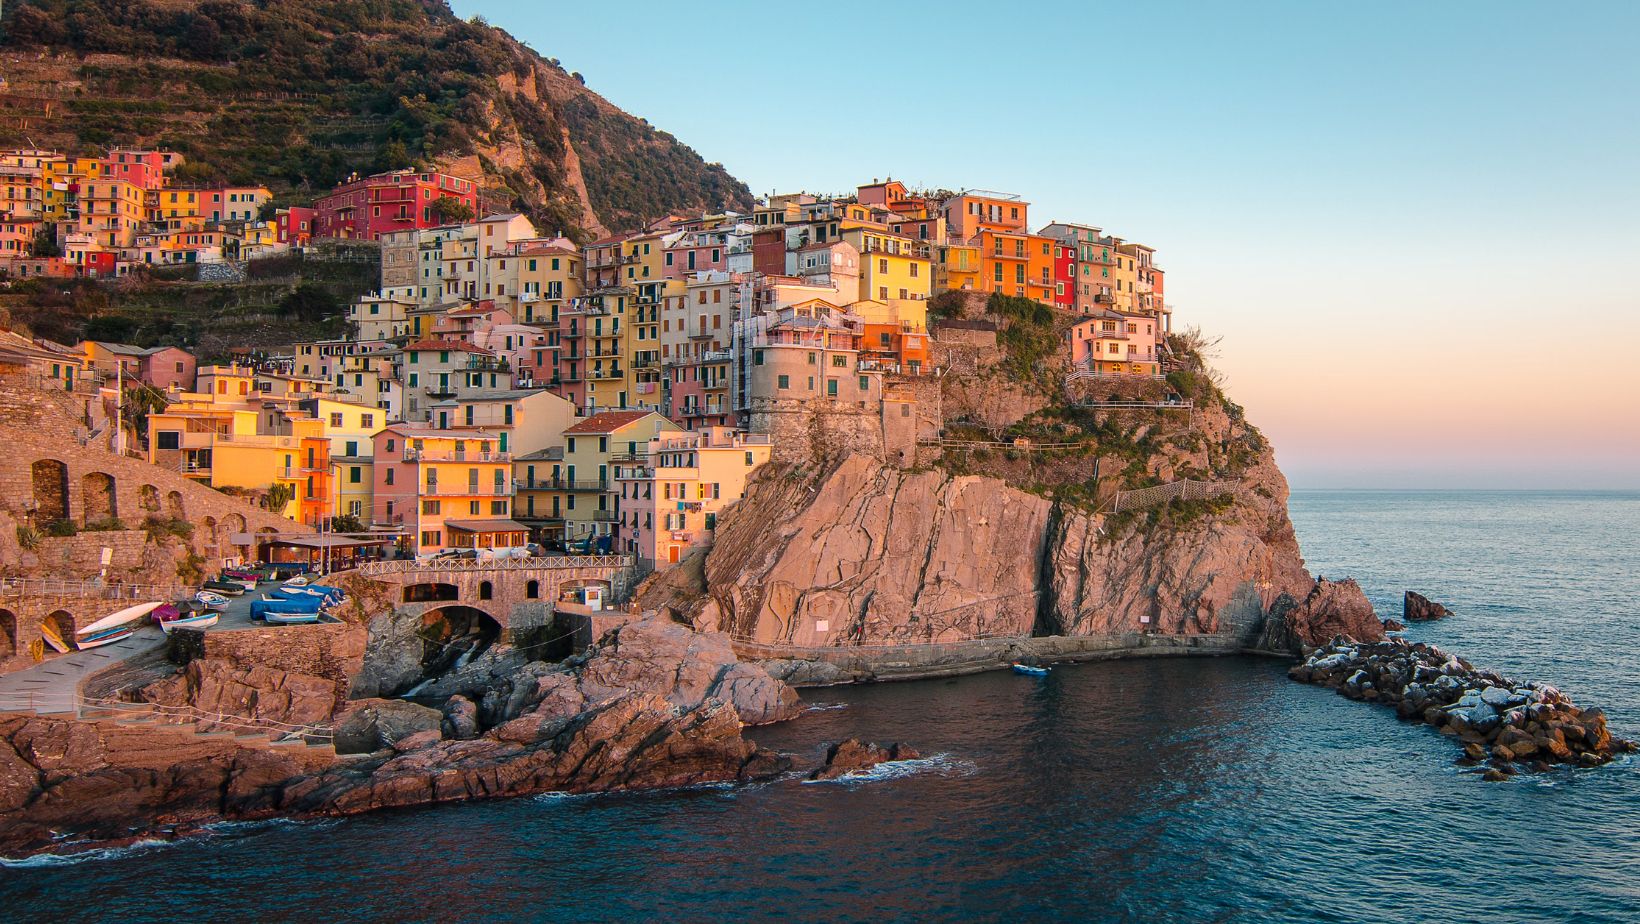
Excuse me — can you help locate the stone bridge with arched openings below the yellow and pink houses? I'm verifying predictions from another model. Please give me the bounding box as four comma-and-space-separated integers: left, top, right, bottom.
358, 555, 636, 637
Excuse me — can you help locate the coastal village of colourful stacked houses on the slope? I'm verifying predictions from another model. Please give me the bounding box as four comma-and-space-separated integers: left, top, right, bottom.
0, 149, 1171, 571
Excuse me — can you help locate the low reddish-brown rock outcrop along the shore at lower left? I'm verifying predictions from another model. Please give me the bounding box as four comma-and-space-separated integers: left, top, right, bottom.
0, 620, 800, 853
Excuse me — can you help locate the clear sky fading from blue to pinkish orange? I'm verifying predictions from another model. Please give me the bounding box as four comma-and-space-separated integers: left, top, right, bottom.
453, 0, 1640, 487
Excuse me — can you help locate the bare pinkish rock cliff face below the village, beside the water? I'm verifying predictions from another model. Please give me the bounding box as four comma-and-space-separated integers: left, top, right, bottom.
686, 379, 1383, 648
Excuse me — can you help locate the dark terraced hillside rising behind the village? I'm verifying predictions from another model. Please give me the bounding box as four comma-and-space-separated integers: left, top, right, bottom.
0, 0, 751, 238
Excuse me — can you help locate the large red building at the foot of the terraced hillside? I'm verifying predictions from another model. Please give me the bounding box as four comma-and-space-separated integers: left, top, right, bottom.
313, 171, 479, 241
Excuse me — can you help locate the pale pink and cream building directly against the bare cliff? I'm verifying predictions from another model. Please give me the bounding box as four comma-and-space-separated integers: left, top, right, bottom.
615, 427, 771, 568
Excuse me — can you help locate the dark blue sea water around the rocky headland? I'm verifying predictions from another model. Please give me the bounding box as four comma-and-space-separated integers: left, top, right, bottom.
0, 492, 1640, 921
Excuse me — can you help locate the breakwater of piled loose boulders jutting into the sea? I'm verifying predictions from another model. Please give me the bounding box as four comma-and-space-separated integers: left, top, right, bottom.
1287, 638, 1635, 780
